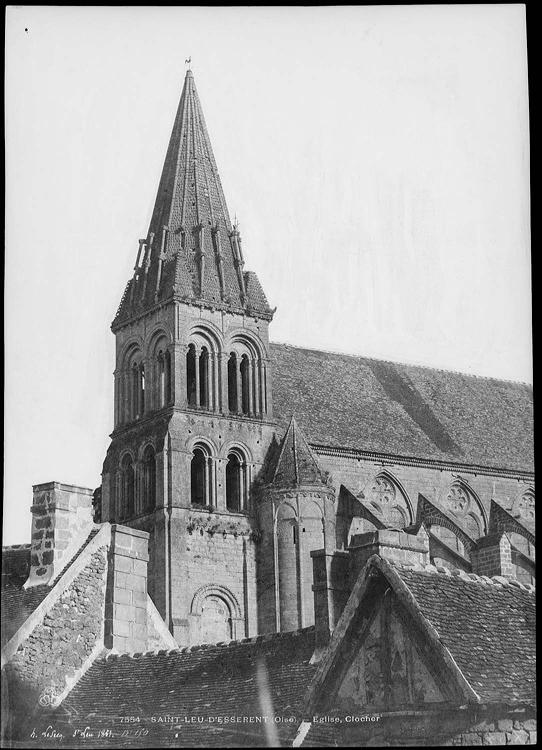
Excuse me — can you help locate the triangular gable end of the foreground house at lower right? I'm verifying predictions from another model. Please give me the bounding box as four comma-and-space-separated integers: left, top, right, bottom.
304, 555, 480, 716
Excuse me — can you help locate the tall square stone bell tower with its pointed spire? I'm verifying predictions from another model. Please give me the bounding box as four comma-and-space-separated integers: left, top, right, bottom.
101, 70, 274, 645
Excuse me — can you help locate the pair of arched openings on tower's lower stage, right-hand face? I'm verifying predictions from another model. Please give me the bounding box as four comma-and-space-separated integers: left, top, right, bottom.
190, 444, 250, 513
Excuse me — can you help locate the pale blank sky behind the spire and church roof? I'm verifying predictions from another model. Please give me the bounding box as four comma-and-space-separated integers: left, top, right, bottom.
4, 4, 532, 544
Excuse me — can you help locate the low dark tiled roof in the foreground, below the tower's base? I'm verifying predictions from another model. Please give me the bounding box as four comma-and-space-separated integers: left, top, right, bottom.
48, 628, 315, 747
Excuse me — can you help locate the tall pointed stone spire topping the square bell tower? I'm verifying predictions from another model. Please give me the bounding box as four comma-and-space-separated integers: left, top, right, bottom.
114, 70, 273, 324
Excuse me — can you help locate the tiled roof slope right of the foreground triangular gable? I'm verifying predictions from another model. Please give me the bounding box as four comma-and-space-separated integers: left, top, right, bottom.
395, 566, 535, 703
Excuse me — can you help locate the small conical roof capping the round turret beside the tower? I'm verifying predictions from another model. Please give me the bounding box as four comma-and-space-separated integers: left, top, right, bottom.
271, 415, 327, 489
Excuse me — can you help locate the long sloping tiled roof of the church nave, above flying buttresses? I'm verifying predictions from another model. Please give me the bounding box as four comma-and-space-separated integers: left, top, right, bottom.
271, 344, 534, 472
